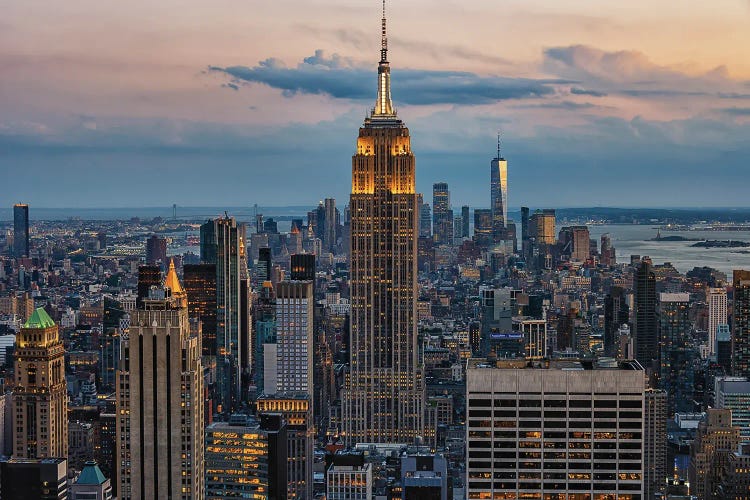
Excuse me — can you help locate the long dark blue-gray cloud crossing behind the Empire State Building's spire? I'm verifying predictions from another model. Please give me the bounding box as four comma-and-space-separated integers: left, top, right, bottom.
209, 50, 564, 105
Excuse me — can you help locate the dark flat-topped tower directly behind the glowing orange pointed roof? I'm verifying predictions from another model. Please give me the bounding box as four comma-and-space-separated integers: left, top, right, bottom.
182, 264, 216, 356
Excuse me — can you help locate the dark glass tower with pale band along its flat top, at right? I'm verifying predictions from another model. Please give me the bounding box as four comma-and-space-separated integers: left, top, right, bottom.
659, 293, 696, 416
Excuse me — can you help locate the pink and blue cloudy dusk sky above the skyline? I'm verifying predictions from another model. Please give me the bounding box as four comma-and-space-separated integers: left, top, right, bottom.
0, 0, 750, 208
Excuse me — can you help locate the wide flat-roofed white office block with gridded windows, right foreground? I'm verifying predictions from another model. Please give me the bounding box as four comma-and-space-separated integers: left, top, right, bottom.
466, 359, 645, 500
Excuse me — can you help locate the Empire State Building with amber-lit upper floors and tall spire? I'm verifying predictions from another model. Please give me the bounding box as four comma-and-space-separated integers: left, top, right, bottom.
342, 1, 424, 444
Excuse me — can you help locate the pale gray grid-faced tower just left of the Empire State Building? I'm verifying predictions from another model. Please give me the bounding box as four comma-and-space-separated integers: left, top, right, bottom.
276, 281, 315, 397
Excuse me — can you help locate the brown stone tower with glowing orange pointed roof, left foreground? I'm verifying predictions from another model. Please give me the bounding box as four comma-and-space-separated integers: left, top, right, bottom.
117, 263, 204, 500
